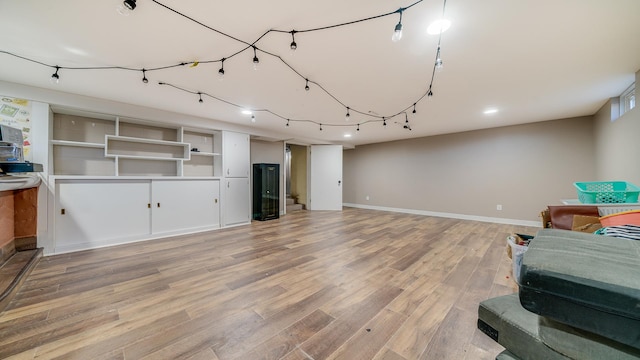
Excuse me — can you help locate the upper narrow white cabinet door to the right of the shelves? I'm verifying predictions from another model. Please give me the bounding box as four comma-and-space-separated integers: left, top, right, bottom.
222, 131, 251, 177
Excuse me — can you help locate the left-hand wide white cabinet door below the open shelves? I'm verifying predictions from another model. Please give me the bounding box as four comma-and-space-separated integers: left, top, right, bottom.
54, 180, 151, 253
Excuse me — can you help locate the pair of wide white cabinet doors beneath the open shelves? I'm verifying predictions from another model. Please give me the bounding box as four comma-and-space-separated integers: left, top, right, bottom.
54, 179, 220, 253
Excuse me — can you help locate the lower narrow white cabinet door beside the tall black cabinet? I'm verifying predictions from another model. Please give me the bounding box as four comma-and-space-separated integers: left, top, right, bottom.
223, 178, 251, 226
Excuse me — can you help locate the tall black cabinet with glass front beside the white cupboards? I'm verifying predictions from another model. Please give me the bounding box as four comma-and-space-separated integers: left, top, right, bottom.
253, 164, 280, 221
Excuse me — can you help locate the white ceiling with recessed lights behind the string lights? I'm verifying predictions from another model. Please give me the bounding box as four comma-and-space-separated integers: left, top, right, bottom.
0, 0, 640, 145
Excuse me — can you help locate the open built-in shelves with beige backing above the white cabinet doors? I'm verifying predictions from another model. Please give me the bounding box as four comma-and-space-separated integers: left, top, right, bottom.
50, 111, 222, 177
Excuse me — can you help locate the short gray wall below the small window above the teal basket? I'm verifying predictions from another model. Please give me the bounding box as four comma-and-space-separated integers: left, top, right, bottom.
595, 71, 640, 186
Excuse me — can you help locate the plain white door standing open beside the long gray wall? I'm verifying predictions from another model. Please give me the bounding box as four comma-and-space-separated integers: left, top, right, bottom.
309, 145, 342, 210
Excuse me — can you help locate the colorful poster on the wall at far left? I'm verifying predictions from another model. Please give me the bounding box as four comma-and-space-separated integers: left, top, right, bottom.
0, 96, 32, 161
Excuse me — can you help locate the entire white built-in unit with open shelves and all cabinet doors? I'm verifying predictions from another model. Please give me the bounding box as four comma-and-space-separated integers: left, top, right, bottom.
48, 109, 250, 253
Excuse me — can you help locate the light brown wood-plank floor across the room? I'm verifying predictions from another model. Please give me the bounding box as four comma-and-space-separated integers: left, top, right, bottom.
0, 208, 537, 360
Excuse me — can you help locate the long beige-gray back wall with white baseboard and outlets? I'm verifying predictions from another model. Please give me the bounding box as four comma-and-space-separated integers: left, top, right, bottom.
343, 116, 596, 221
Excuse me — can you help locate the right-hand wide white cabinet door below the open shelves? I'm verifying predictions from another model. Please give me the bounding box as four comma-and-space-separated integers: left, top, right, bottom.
151, 179, 220, 234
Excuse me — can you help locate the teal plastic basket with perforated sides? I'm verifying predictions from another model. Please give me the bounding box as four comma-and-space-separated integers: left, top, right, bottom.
573, 181, 640, 204
